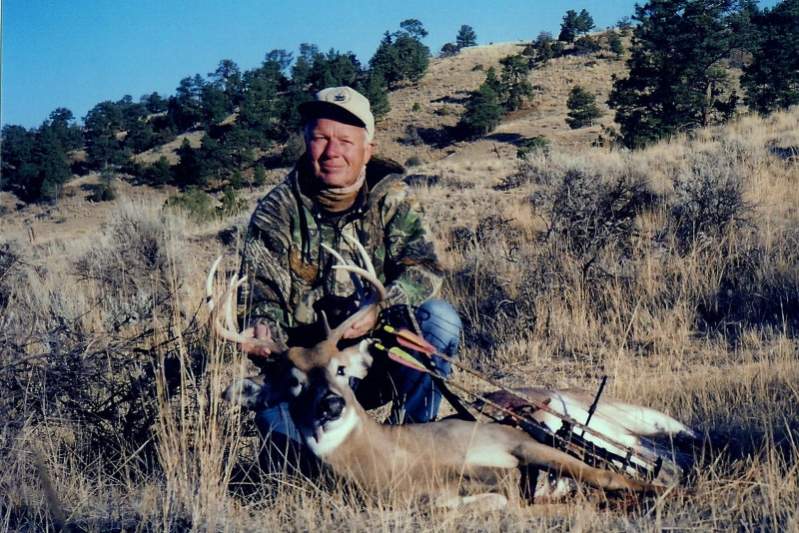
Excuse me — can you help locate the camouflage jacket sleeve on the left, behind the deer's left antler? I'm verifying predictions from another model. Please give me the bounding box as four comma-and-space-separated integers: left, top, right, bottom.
237, 194, 291, 342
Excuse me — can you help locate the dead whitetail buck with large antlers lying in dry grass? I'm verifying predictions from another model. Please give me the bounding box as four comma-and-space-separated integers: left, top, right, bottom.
207, 243, 690, 507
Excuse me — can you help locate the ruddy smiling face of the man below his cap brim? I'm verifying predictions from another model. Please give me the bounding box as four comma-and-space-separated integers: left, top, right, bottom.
306, 118, 372, 188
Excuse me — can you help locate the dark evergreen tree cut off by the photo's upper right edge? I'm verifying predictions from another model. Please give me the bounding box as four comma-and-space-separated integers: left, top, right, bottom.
741, 0, 799, 113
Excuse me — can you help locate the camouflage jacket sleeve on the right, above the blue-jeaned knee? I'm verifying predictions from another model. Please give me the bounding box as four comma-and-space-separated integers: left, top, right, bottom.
384, 182, 443, 307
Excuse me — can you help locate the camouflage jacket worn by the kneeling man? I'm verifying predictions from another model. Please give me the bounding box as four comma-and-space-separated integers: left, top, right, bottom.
238, 159, 442, 344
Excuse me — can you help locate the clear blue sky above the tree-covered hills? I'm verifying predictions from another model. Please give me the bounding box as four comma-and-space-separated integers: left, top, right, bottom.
0, 0, 768, 127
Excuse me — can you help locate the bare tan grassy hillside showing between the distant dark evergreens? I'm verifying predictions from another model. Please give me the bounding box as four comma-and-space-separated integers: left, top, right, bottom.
0, 38, 624, 242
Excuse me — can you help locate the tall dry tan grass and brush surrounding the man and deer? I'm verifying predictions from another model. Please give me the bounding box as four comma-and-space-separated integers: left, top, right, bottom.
0, 111, 799, 531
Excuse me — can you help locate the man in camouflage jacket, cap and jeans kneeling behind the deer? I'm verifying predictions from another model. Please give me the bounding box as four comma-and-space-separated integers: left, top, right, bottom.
239, 87, 461, 470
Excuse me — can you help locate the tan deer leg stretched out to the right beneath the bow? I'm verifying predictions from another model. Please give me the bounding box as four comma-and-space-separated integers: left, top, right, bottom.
511, 438, 654, 492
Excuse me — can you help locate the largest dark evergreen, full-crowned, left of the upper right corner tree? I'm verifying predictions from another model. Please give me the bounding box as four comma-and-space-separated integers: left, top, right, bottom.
608, 0, 732, 148
